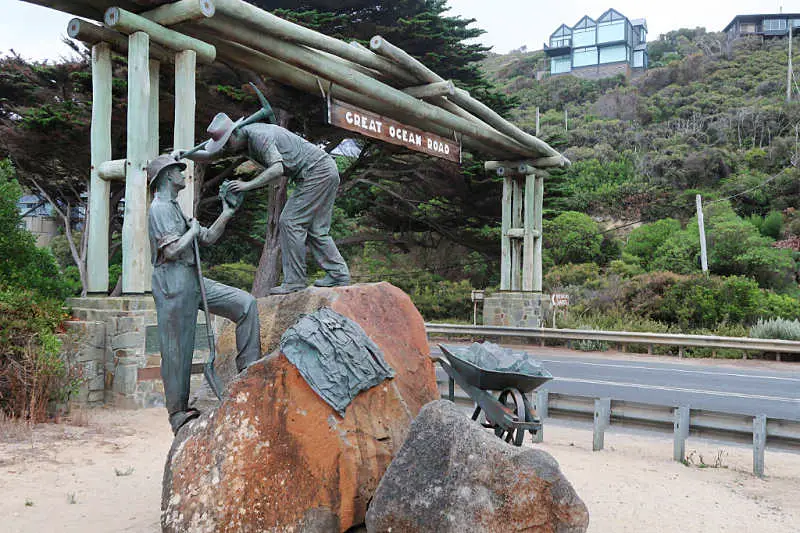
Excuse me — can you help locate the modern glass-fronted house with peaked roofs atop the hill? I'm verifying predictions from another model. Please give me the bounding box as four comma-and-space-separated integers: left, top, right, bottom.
544, 9, 647, 79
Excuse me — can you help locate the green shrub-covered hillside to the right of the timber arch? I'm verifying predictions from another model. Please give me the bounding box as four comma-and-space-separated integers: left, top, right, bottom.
484, 29, 800, 350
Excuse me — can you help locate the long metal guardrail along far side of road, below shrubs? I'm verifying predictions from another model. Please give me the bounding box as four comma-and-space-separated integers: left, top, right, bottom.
432, 323, 800, 354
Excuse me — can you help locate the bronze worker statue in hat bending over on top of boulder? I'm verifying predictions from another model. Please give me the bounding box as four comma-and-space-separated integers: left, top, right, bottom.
174, 113, 350, 294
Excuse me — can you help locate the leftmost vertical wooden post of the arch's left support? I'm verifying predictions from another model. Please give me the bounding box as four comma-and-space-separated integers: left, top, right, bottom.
86, 43, 112, 294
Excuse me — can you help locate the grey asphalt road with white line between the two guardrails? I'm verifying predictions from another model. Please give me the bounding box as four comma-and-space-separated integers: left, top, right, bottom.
431, 345, 800, 421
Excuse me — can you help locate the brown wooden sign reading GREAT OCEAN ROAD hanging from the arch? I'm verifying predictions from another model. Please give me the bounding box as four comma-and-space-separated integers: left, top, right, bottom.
328, 99, 461, 163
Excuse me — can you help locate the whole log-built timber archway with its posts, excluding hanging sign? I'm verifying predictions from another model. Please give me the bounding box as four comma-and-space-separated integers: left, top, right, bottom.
24, 0, 569, 294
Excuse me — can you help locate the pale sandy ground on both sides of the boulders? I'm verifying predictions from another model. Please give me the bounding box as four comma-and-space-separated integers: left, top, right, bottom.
0, 409, 800, 533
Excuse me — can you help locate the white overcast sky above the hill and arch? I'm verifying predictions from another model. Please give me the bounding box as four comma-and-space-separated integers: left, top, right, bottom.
0, 0, 788, 60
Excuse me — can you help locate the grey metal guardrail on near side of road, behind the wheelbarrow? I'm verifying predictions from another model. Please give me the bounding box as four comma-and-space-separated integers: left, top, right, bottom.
436, 368, 800, 477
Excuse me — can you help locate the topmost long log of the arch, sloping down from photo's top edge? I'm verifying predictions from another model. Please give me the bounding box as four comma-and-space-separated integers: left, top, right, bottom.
214, 0, 417, 85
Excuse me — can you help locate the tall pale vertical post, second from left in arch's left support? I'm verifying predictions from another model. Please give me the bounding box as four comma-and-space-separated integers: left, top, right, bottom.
122, 32, 150, 294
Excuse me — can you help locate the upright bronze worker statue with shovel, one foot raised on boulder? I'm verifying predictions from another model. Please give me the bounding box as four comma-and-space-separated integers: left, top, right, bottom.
147, 155, 261, 433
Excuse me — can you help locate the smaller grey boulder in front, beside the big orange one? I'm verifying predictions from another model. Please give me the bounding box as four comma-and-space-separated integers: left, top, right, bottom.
367, 400, 589, 533
